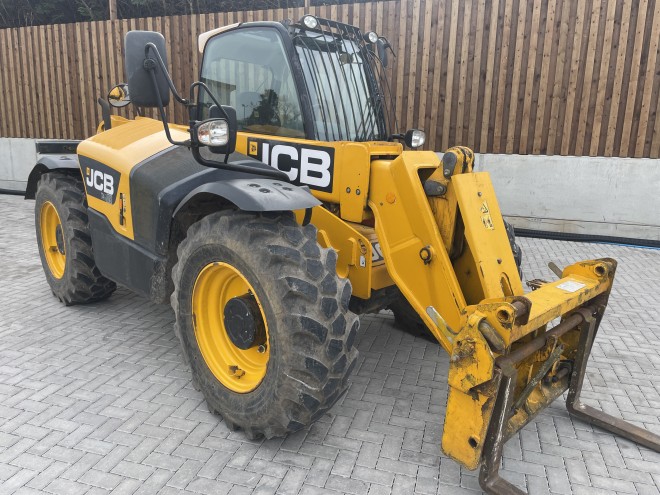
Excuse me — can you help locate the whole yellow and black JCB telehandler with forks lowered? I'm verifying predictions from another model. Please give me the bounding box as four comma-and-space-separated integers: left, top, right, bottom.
26, 15, 660, 493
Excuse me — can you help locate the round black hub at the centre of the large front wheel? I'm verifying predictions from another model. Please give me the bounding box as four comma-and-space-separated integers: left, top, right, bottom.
224, 294, 266, 350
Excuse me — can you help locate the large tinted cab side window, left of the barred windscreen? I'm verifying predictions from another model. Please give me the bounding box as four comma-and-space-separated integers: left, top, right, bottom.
201, 28, 305, 138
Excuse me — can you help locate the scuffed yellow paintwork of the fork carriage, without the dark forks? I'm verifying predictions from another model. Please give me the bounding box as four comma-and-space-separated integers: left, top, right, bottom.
442, 258, 616, 469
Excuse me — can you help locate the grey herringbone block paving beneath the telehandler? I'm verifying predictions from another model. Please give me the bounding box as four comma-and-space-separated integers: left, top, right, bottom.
0, 196, 660, 494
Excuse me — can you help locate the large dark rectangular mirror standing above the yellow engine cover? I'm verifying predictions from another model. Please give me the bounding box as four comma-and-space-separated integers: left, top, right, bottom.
124, 31, 170, 108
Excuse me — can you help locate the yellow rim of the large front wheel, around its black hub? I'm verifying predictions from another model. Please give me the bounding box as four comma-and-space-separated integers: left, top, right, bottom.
192, 262, 270, 394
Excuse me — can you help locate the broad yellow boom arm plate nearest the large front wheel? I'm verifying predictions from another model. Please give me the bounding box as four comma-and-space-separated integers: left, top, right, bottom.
369, 151, 465, 352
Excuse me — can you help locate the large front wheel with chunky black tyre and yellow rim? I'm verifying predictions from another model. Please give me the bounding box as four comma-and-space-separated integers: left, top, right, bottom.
171, 210, 359, 438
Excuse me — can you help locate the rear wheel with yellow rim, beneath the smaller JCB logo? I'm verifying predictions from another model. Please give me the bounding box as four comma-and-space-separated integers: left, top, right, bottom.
34, 173, 117, 306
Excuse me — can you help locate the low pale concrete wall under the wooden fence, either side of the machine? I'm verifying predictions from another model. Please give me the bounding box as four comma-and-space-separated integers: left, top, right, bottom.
0, 138, 660, 241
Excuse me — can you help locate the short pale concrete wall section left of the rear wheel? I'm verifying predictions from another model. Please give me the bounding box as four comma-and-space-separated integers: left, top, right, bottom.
0, 137, 37, 191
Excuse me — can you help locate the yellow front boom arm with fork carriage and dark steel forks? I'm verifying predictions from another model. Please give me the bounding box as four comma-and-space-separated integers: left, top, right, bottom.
368, 152, 660, 493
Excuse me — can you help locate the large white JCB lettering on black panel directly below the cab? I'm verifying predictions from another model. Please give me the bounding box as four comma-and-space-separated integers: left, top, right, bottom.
247, 138, 335, 196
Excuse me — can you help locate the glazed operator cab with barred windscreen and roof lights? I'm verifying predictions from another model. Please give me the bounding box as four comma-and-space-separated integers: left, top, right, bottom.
199, 15, 399, 142
